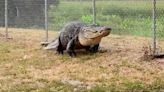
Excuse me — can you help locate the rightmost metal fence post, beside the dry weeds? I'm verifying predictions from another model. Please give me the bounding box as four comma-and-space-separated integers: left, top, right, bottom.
152, 0, 156, 55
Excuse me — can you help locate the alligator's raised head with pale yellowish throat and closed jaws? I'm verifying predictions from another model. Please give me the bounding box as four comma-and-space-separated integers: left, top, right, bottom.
78, 26, 111, 46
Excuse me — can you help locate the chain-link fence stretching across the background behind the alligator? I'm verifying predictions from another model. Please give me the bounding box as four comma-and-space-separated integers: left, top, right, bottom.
0, 0, 164, 56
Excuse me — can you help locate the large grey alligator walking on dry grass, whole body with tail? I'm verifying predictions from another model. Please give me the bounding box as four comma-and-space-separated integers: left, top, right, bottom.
42, 22, 111, 57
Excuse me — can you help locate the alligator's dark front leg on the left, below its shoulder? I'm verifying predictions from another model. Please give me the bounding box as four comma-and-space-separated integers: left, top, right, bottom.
66, 39, 76, 57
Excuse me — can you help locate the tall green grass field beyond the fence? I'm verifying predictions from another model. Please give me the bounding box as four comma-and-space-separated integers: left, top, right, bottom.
49, 0, 164, 38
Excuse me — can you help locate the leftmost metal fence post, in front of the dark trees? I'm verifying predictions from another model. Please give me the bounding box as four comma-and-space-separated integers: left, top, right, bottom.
5, 0, 8, 39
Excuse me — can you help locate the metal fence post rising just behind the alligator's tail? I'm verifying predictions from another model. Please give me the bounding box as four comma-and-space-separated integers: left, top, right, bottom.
45, 0, 48, 42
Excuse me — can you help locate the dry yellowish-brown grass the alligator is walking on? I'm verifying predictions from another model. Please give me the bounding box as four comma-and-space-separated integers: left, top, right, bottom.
0, 28, 164, 92
